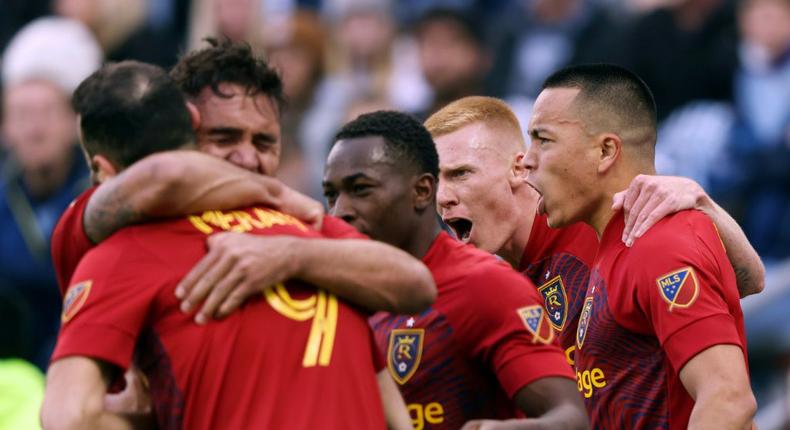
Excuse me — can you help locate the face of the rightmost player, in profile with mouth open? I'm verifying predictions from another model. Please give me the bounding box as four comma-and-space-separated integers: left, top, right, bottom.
524, 88, 597, 227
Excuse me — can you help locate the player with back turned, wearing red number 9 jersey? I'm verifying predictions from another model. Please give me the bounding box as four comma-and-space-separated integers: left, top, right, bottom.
42, 62, 407, 429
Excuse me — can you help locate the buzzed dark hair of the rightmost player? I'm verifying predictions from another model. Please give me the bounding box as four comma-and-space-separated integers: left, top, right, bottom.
543, 64, 657, 138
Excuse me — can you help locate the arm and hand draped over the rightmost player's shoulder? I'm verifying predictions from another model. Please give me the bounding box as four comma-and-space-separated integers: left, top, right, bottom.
613, 175, 765, 297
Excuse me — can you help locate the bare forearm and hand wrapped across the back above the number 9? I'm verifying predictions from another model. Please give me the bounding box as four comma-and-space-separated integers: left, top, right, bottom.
176, 233, 436, 322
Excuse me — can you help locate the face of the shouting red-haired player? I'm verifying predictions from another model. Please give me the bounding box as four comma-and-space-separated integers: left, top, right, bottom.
435, 123, 518, 253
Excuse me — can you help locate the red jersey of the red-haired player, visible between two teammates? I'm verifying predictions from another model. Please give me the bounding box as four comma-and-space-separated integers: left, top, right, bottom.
519, 214, 598, 358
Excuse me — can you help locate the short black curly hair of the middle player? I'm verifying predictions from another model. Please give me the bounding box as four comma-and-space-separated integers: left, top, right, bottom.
335, 110, 439, 176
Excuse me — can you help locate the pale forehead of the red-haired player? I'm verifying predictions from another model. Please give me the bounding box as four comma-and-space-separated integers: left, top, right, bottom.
434, 122, 507, 168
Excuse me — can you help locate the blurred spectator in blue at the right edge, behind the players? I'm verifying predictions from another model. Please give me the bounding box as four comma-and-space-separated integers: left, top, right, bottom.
712, 0, 790, 260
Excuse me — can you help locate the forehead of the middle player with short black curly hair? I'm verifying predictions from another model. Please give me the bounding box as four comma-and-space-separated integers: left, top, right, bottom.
326, 136, 397, 179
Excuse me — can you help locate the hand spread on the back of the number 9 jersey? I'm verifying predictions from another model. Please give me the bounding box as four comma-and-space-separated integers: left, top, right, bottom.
176, 233, 298, 324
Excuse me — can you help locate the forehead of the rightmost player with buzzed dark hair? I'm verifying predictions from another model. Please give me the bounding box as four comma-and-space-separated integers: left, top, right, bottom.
529, 88, 582, 132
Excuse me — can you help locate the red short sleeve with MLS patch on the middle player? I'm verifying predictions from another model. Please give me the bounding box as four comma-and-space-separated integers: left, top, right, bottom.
453, 263, 574, 398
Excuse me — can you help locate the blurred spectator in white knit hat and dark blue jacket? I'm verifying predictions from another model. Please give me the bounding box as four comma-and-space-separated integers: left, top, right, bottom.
0, 18, 101, 367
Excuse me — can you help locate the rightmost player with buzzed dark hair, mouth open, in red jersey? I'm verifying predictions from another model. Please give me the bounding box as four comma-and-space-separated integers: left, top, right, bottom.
525, 65, 756, 429
